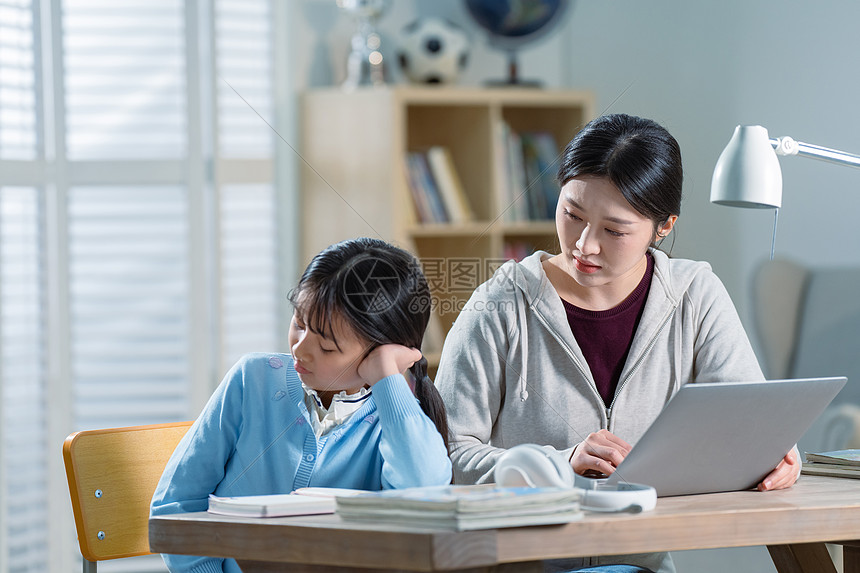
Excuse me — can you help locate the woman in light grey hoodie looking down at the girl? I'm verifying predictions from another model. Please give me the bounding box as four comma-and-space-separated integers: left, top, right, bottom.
436, 115, 800, 571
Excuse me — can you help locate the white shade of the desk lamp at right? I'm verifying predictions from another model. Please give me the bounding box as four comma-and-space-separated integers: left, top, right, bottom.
711, 125, 782, 209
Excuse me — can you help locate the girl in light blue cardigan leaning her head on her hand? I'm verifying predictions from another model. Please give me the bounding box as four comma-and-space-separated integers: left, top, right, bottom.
151, 239, 451, 573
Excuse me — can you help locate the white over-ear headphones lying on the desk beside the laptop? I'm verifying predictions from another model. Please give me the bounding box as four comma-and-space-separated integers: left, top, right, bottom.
495, 444, 657, 513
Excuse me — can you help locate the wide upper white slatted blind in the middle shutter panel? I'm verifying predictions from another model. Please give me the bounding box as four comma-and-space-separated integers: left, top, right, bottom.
62, 0, 188, 160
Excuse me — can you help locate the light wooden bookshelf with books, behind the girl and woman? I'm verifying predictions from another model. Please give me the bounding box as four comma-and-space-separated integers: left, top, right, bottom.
299, 86, 594, 364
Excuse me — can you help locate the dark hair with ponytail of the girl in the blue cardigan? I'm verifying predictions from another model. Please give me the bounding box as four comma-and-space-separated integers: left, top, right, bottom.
290, 238, 448, 448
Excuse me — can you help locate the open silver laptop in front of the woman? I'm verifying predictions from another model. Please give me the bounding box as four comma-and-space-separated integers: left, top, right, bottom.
602, 377, 847, 497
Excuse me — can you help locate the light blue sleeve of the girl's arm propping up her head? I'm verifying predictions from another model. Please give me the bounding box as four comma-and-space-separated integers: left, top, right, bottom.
373, 374, 451, 489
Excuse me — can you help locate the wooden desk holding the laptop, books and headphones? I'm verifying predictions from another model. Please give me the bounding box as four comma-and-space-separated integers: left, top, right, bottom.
149, 476, 860, 573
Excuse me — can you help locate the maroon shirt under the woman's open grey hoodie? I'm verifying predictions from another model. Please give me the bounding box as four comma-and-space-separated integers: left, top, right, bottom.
561, 253, 654, 407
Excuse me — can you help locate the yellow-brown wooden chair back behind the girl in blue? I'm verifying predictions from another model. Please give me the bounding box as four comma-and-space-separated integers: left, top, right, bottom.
63, 422, 191, 573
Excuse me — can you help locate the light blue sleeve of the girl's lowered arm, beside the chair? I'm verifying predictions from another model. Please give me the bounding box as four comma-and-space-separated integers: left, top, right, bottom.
150, 361, 245, 573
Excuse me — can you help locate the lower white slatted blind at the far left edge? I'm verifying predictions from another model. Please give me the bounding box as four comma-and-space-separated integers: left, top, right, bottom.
0, 187, 47, 573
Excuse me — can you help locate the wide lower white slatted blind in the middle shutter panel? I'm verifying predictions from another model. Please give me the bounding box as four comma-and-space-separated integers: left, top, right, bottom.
69, 185, 191, 429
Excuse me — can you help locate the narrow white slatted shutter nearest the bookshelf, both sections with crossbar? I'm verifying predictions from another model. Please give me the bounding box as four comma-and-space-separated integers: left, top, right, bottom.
214, 0, 278, 373
